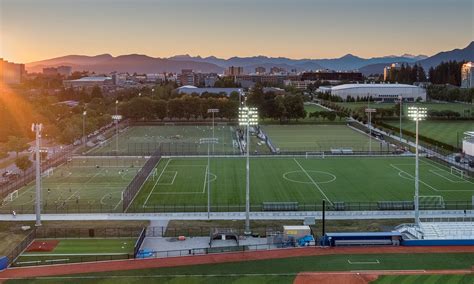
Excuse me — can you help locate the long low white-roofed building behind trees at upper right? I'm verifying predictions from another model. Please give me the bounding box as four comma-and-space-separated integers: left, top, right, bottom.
318, 84, 426, 102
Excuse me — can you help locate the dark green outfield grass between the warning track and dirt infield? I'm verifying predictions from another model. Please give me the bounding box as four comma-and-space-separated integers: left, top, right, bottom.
8, 253, 474, 283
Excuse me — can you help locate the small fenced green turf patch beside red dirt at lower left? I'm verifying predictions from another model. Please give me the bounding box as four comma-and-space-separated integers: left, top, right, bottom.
14, 238, 136, 266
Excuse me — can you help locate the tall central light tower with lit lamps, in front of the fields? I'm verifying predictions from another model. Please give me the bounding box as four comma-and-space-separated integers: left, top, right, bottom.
239, 106, 258, 235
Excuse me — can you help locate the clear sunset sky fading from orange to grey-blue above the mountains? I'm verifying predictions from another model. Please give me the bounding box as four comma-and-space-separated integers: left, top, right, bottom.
0, 0, 474, 63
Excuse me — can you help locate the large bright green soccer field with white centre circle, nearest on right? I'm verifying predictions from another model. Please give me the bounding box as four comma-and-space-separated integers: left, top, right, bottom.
130, 157, 474, 211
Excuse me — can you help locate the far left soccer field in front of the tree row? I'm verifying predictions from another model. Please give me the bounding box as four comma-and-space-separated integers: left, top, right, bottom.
89, 124, 239, 155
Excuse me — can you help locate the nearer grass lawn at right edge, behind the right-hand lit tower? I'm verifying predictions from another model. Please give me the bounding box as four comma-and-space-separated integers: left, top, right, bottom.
386, 120, 474, 147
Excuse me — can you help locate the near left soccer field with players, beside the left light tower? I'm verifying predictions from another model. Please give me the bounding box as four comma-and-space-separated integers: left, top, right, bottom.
0, 157, 146, 213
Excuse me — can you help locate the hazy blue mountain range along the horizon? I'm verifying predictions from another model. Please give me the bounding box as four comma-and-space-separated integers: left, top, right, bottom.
26, 41, 474, 75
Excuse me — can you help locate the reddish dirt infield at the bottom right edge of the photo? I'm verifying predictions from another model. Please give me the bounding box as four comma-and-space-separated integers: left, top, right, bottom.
293, 270, 472, 284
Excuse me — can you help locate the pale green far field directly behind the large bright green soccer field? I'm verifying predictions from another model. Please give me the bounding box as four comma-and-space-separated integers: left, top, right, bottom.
261, 124, 389, 152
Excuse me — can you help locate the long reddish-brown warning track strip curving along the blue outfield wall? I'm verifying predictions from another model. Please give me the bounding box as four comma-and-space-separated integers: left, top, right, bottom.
0, 246, 474, 279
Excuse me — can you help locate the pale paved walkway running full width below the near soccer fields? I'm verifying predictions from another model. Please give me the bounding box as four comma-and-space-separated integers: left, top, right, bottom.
0, 210, 474, 221
